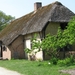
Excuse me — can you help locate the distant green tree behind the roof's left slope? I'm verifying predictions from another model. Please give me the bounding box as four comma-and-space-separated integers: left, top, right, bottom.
0, 11, 15, 31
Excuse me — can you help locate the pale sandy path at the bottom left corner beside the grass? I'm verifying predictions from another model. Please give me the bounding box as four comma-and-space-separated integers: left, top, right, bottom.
0, 67, 22, 75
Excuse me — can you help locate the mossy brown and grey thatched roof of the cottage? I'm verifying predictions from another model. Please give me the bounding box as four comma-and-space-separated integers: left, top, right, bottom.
0, 2, 74, 45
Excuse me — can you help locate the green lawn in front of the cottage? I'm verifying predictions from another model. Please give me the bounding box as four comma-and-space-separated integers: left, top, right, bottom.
0, 60, 75, 75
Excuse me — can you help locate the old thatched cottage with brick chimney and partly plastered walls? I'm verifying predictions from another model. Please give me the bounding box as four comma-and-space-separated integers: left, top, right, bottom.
0, 1, 74, 60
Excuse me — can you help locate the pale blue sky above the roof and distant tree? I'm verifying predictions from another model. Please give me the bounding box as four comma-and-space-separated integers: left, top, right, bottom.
0, 0, 75, 18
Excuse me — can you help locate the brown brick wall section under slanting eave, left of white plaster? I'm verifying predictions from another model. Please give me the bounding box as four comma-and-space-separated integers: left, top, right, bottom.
8, 36, 25, 59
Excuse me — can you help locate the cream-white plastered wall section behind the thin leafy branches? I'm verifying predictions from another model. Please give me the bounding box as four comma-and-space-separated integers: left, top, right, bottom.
25, 33, 43, 60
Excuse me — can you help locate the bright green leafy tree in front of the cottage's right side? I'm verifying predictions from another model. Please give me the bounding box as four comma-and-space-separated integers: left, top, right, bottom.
25, 17, 75, 57
